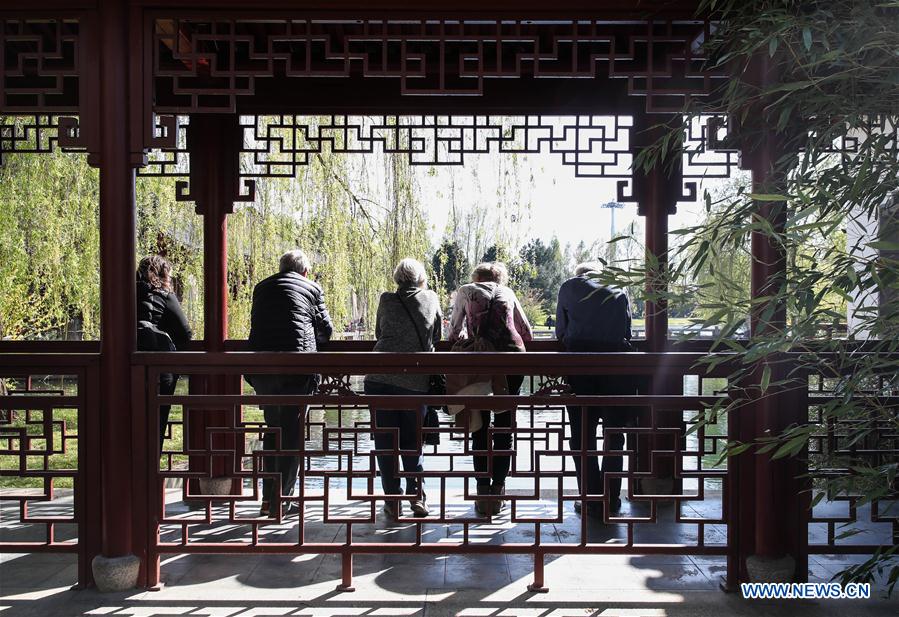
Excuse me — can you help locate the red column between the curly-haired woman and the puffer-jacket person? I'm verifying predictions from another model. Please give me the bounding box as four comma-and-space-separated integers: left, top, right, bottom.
187, 114, 252, 495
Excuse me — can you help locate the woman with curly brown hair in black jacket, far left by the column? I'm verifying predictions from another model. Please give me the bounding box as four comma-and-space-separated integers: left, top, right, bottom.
137, 255, 193, 450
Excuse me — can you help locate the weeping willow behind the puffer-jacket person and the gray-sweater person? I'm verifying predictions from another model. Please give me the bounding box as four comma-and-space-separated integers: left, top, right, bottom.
229, 117, 429, 338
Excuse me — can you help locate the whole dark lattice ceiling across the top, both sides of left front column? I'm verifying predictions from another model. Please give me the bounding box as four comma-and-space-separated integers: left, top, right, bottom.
0, 0, 722, 161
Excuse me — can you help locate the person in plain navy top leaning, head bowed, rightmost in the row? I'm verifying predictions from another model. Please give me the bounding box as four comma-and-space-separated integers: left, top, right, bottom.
556, 263, 637, 516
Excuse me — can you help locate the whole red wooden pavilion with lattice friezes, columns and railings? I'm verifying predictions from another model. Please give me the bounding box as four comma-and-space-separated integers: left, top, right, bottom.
0, 0, 875, 589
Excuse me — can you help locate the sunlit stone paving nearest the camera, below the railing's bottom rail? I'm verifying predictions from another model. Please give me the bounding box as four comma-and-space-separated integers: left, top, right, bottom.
0, 540, 899, 617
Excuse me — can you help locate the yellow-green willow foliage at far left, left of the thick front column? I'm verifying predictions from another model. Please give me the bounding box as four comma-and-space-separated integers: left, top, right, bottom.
0, 135, 100, 338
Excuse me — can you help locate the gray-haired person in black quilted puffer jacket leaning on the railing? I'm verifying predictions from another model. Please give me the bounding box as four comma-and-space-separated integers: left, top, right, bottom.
247, 250, 334, 516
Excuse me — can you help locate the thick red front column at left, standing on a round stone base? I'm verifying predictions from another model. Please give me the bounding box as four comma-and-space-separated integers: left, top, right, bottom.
92, 0, 147, 591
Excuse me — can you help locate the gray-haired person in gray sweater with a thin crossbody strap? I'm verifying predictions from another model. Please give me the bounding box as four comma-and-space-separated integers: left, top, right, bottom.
365, 257, 443, 520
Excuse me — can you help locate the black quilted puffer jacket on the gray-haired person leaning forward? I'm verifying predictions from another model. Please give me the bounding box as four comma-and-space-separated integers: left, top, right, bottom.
249, 272, 334, 351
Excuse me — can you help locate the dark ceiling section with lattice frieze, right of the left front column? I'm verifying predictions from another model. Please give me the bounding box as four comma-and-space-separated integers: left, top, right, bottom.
152, 13, 715, 113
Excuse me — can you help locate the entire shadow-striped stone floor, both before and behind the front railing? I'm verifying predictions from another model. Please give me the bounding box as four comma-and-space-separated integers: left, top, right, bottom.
0, 491, 899, 617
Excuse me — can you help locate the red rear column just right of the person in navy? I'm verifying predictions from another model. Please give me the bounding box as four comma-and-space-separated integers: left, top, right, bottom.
631, 114, 683, 494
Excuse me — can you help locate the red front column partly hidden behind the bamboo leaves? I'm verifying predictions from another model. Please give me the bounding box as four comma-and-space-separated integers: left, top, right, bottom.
739, 51, 808, 582
